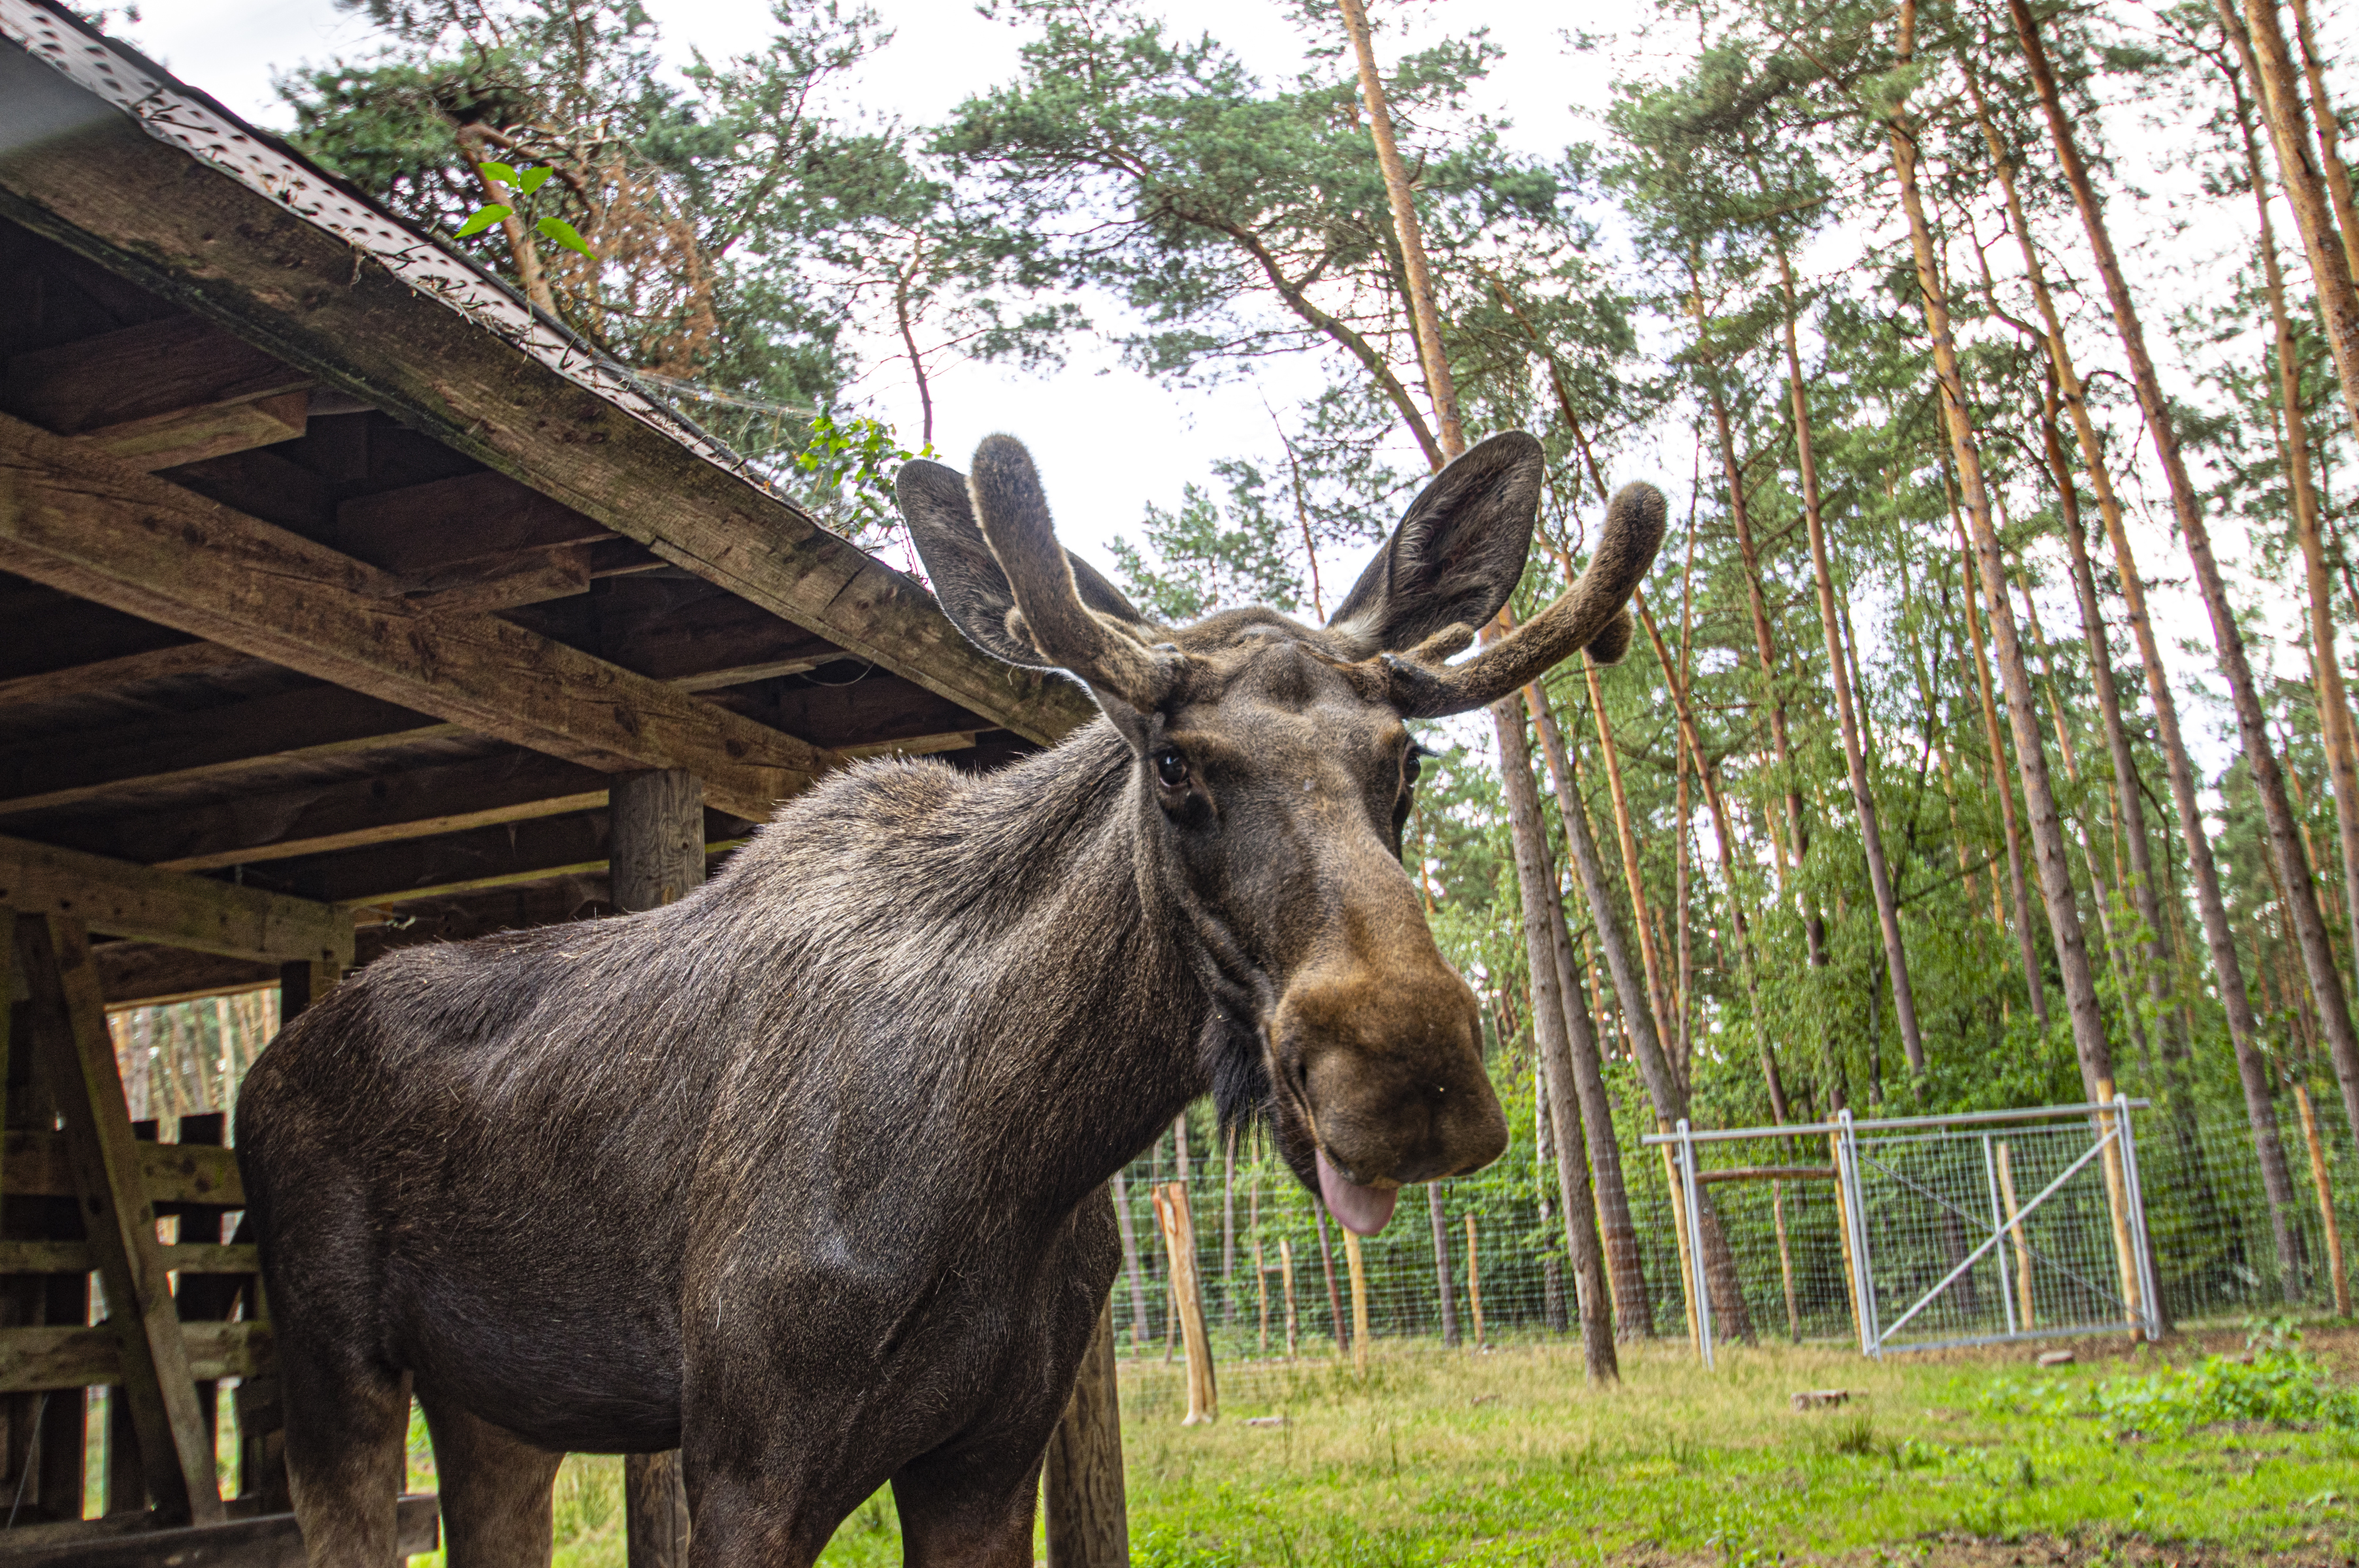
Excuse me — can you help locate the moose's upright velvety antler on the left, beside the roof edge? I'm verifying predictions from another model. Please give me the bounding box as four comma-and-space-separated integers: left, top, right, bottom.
967, 436, 1187, 712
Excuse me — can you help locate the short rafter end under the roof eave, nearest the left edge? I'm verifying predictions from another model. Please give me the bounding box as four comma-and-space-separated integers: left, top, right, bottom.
0, 316, 312, 472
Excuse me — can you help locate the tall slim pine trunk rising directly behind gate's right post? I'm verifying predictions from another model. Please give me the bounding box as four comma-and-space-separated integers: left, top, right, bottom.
1892, 0, 2114, 1099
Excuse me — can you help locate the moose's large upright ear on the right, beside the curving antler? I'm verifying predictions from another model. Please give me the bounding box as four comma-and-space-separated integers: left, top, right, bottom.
1328, 429, 1540, 655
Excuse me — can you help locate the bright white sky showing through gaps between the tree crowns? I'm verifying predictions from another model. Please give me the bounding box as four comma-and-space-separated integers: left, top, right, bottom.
101, 0, 2330, 787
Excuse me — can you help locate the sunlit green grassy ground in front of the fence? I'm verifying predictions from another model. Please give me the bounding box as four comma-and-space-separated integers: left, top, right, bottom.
405, 1332, 2359, 1568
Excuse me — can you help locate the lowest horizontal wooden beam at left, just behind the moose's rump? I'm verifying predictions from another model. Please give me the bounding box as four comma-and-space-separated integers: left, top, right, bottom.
0, 837, 352, 964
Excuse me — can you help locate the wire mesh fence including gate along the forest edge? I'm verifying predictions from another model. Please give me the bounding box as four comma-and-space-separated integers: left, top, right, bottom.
1114, 1099, 2359, 1360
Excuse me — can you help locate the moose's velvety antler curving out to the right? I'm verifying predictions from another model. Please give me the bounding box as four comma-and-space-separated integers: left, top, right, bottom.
1382, 483, 1663, 719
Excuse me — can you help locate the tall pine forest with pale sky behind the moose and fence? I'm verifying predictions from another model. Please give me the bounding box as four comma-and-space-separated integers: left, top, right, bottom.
91, 0, 2359, 1348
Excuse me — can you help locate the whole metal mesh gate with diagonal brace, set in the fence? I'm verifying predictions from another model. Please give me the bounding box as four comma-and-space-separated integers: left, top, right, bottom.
1647, 1096, 2161, 1365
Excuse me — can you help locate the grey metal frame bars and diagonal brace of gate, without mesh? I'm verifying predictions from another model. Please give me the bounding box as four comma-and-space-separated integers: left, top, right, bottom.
1640, 1094, 2163, 1367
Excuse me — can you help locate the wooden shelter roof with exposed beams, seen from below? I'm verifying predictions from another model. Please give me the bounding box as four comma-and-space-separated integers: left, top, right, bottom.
0, 0, 1092, 1002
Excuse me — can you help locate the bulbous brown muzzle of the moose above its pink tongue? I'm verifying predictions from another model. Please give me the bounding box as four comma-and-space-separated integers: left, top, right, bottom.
1272, 955, 1508, 1188
